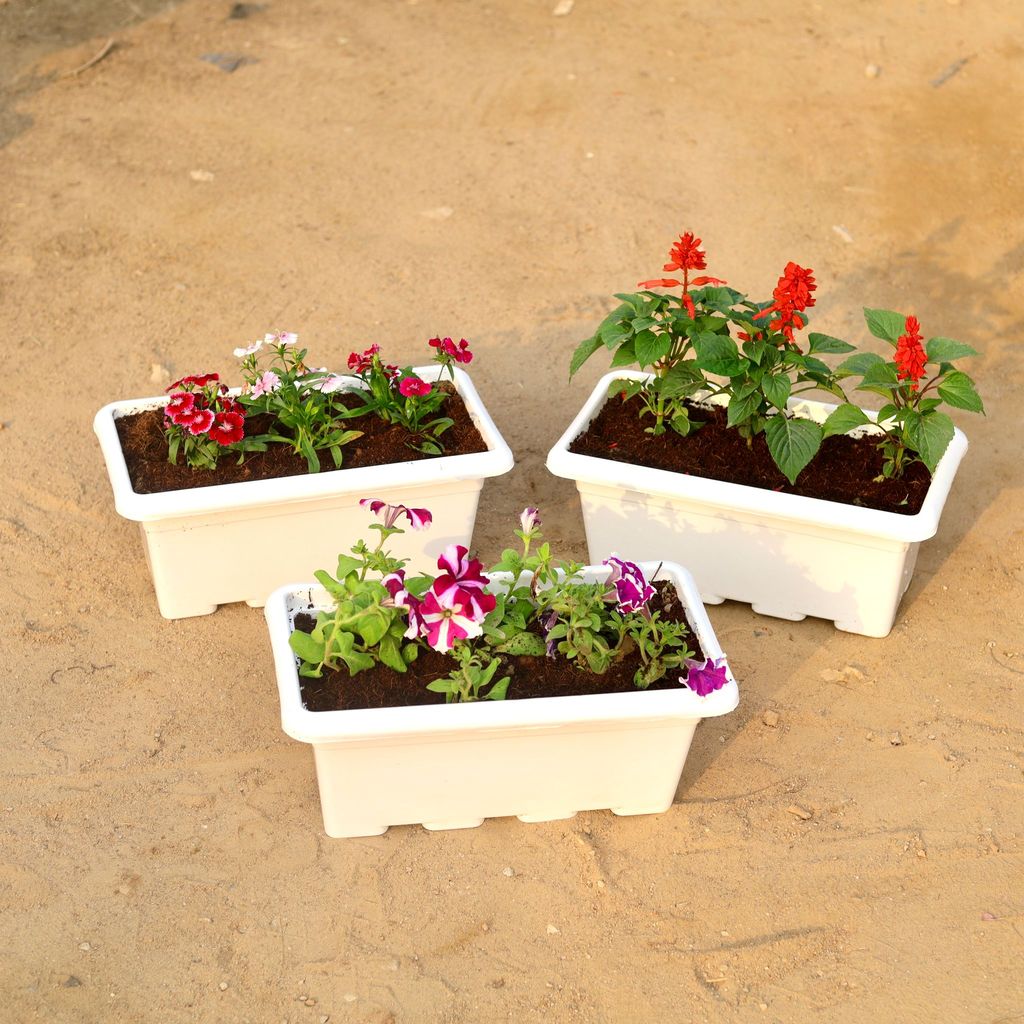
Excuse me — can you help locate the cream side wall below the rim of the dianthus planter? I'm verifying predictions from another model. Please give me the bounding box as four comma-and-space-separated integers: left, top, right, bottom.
139, 479, 483, 618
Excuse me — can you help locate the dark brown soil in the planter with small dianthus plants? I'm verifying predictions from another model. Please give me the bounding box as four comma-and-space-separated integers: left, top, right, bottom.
117, 385, 487, 495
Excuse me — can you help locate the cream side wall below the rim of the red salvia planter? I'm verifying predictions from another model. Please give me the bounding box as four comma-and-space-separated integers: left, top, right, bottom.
577, 480, 920, 637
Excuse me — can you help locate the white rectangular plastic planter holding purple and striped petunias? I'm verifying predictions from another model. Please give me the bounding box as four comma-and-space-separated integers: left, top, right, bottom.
265, 562, 739, 837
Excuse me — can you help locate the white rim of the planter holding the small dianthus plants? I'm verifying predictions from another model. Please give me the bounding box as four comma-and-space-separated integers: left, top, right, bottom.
93, 364, 513, 522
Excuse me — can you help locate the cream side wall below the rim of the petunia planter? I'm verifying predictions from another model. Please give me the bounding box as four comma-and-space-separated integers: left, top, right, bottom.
313, 719, 699, 838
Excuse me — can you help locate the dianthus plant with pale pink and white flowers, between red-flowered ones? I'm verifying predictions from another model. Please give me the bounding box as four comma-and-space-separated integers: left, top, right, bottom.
234, 333, 362, 473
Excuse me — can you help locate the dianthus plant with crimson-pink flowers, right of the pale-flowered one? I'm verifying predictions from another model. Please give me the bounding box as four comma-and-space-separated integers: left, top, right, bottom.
348, 338, 473, 455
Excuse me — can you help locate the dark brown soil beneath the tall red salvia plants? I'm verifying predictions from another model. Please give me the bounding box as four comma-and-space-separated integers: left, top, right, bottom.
569, 387, 932, 515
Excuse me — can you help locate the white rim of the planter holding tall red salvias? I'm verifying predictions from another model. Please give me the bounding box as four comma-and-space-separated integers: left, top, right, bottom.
547, 370, 968, 543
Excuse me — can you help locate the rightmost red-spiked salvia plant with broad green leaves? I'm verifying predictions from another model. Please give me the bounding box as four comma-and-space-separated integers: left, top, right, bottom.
824, 309, 985, 478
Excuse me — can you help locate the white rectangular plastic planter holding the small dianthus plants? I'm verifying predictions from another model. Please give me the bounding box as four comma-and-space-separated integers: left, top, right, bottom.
93, 365, 512, 618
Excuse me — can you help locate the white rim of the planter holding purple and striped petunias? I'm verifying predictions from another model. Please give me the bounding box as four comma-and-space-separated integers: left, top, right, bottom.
264, 561, 739, 743
